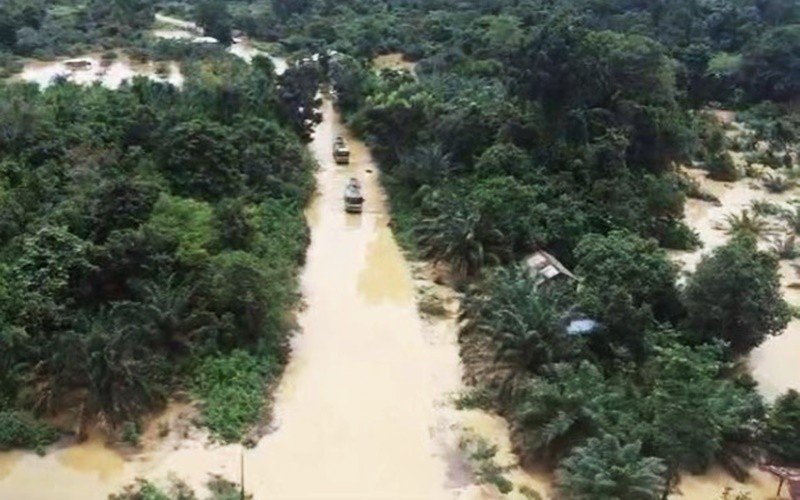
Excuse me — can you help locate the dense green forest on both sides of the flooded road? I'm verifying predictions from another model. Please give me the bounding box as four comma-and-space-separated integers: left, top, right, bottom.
0, 0, 800, 499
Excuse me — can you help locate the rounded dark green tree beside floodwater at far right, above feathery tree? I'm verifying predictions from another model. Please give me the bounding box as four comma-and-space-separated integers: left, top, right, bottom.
684, 235, 791, 353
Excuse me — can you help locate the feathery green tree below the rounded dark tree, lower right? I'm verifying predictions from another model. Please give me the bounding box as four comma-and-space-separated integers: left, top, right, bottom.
631, 338, 764, 481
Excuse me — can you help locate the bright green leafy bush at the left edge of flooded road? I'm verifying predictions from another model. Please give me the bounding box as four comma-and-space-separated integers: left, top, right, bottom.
194, 351, 280, 442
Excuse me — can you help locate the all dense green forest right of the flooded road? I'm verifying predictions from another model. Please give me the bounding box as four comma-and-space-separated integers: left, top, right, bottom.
227, 0, 800, 499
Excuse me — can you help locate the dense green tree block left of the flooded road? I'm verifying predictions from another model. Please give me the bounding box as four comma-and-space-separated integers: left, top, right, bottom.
0, 52, 313, 446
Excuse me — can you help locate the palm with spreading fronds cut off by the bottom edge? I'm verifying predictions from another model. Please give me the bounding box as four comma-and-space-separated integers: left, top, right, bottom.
556, 434, 666, 500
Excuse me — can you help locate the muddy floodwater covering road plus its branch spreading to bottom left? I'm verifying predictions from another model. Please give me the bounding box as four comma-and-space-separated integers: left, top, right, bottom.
0, 97, 546, 500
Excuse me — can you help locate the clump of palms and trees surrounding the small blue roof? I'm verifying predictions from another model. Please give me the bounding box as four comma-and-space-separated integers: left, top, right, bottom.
461, 232, 780, 492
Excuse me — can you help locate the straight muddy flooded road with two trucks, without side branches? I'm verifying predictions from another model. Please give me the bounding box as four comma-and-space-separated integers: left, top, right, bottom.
245, 96, 466, 498
